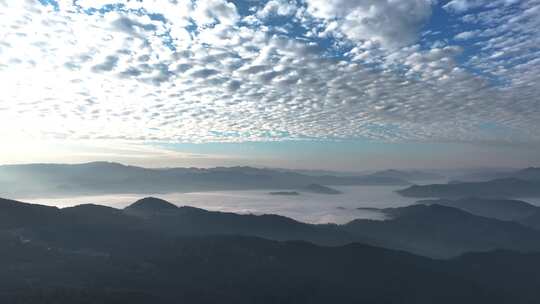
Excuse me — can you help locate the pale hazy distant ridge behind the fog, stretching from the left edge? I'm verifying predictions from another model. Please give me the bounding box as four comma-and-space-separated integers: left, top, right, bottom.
0, 162, 409, 197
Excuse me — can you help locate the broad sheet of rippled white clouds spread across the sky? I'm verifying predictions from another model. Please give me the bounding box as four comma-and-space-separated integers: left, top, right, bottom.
0, 0, 540, 148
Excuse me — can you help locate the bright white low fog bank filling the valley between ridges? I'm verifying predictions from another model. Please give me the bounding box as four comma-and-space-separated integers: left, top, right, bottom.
22, 186, 417, 224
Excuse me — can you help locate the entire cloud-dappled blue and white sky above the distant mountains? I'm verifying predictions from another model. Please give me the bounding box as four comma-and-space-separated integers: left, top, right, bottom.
0, 0, 540, 170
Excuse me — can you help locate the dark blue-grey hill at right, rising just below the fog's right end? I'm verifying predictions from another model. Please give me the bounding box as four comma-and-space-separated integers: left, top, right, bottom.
344, 205, 540, 258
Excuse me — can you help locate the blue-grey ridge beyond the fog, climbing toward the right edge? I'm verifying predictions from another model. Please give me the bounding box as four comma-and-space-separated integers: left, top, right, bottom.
398, 168, 540, 198
